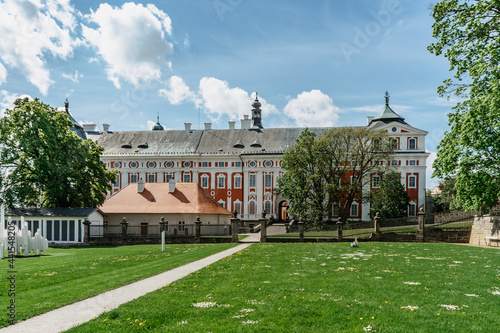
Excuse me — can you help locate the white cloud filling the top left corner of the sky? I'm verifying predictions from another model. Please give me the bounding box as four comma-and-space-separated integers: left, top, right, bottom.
0, 0, 80, 95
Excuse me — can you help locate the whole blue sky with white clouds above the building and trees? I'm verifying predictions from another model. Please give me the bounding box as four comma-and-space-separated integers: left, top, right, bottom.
0, 0, 453, 187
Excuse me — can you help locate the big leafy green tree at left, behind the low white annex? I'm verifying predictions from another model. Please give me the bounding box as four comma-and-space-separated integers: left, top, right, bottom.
0, 98, 115, 208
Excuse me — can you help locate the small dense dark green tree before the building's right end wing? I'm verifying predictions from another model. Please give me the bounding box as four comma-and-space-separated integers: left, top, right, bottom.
370, 172, 410, 219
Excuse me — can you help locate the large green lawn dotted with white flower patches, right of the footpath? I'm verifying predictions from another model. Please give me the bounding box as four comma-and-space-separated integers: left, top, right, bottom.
69, 243, 500, 332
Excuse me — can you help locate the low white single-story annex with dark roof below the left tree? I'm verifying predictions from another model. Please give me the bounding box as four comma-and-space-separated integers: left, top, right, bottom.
4, 208, 103, 244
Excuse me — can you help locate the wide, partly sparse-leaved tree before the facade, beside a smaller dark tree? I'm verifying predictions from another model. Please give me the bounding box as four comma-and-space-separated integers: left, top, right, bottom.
278, 127, 394, 224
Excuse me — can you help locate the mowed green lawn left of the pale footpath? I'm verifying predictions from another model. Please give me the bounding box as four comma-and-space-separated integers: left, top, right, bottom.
0, 244, 238, 326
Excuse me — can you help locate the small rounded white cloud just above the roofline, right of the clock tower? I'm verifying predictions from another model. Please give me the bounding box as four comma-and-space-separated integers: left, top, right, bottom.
284, 90, 339, 127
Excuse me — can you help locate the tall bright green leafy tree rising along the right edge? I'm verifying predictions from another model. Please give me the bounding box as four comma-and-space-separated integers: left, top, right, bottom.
429, 0, 500, 212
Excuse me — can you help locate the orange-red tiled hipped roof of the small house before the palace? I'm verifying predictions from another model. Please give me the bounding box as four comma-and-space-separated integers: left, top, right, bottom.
100, 183, 231, 215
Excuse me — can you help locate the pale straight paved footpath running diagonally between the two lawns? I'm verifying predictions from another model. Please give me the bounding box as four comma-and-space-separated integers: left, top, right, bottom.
0, 244, 252, 333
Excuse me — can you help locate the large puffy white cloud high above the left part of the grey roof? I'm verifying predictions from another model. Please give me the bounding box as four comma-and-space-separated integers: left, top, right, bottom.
82, 2, 173, 88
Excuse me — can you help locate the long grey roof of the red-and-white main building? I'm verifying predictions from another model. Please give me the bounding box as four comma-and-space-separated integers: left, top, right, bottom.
90, 127, 336, 156
